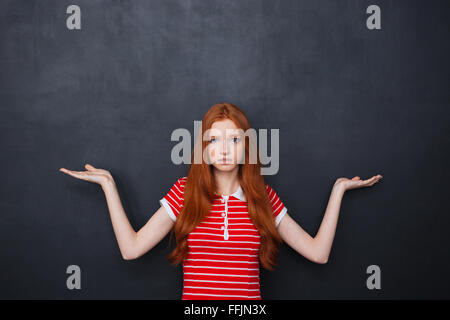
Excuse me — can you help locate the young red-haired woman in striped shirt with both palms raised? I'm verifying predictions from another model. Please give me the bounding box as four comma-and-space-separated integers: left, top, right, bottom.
60, 103, 382, 300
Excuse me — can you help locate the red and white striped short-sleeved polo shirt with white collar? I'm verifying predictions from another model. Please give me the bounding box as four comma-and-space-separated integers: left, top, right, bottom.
159, 177, 287, 300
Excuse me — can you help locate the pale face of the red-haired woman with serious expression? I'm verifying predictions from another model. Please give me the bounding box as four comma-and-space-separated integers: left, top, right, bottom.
205, 119, 245, 171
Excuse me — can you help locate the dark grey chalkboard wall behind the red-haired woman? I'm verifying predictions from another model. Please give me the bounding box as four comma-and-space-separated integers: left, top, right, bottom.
0, 0, 450, 299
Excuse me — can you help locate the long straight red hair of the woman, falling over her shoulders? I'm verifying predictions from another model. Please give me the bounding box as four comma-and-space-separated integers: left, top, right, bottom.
167, 102, 282, 270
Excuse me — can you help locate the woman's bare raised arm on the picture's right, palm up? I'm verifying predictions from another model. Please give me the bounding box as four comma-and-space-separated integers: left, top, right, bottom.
278, 175, 382, 264
